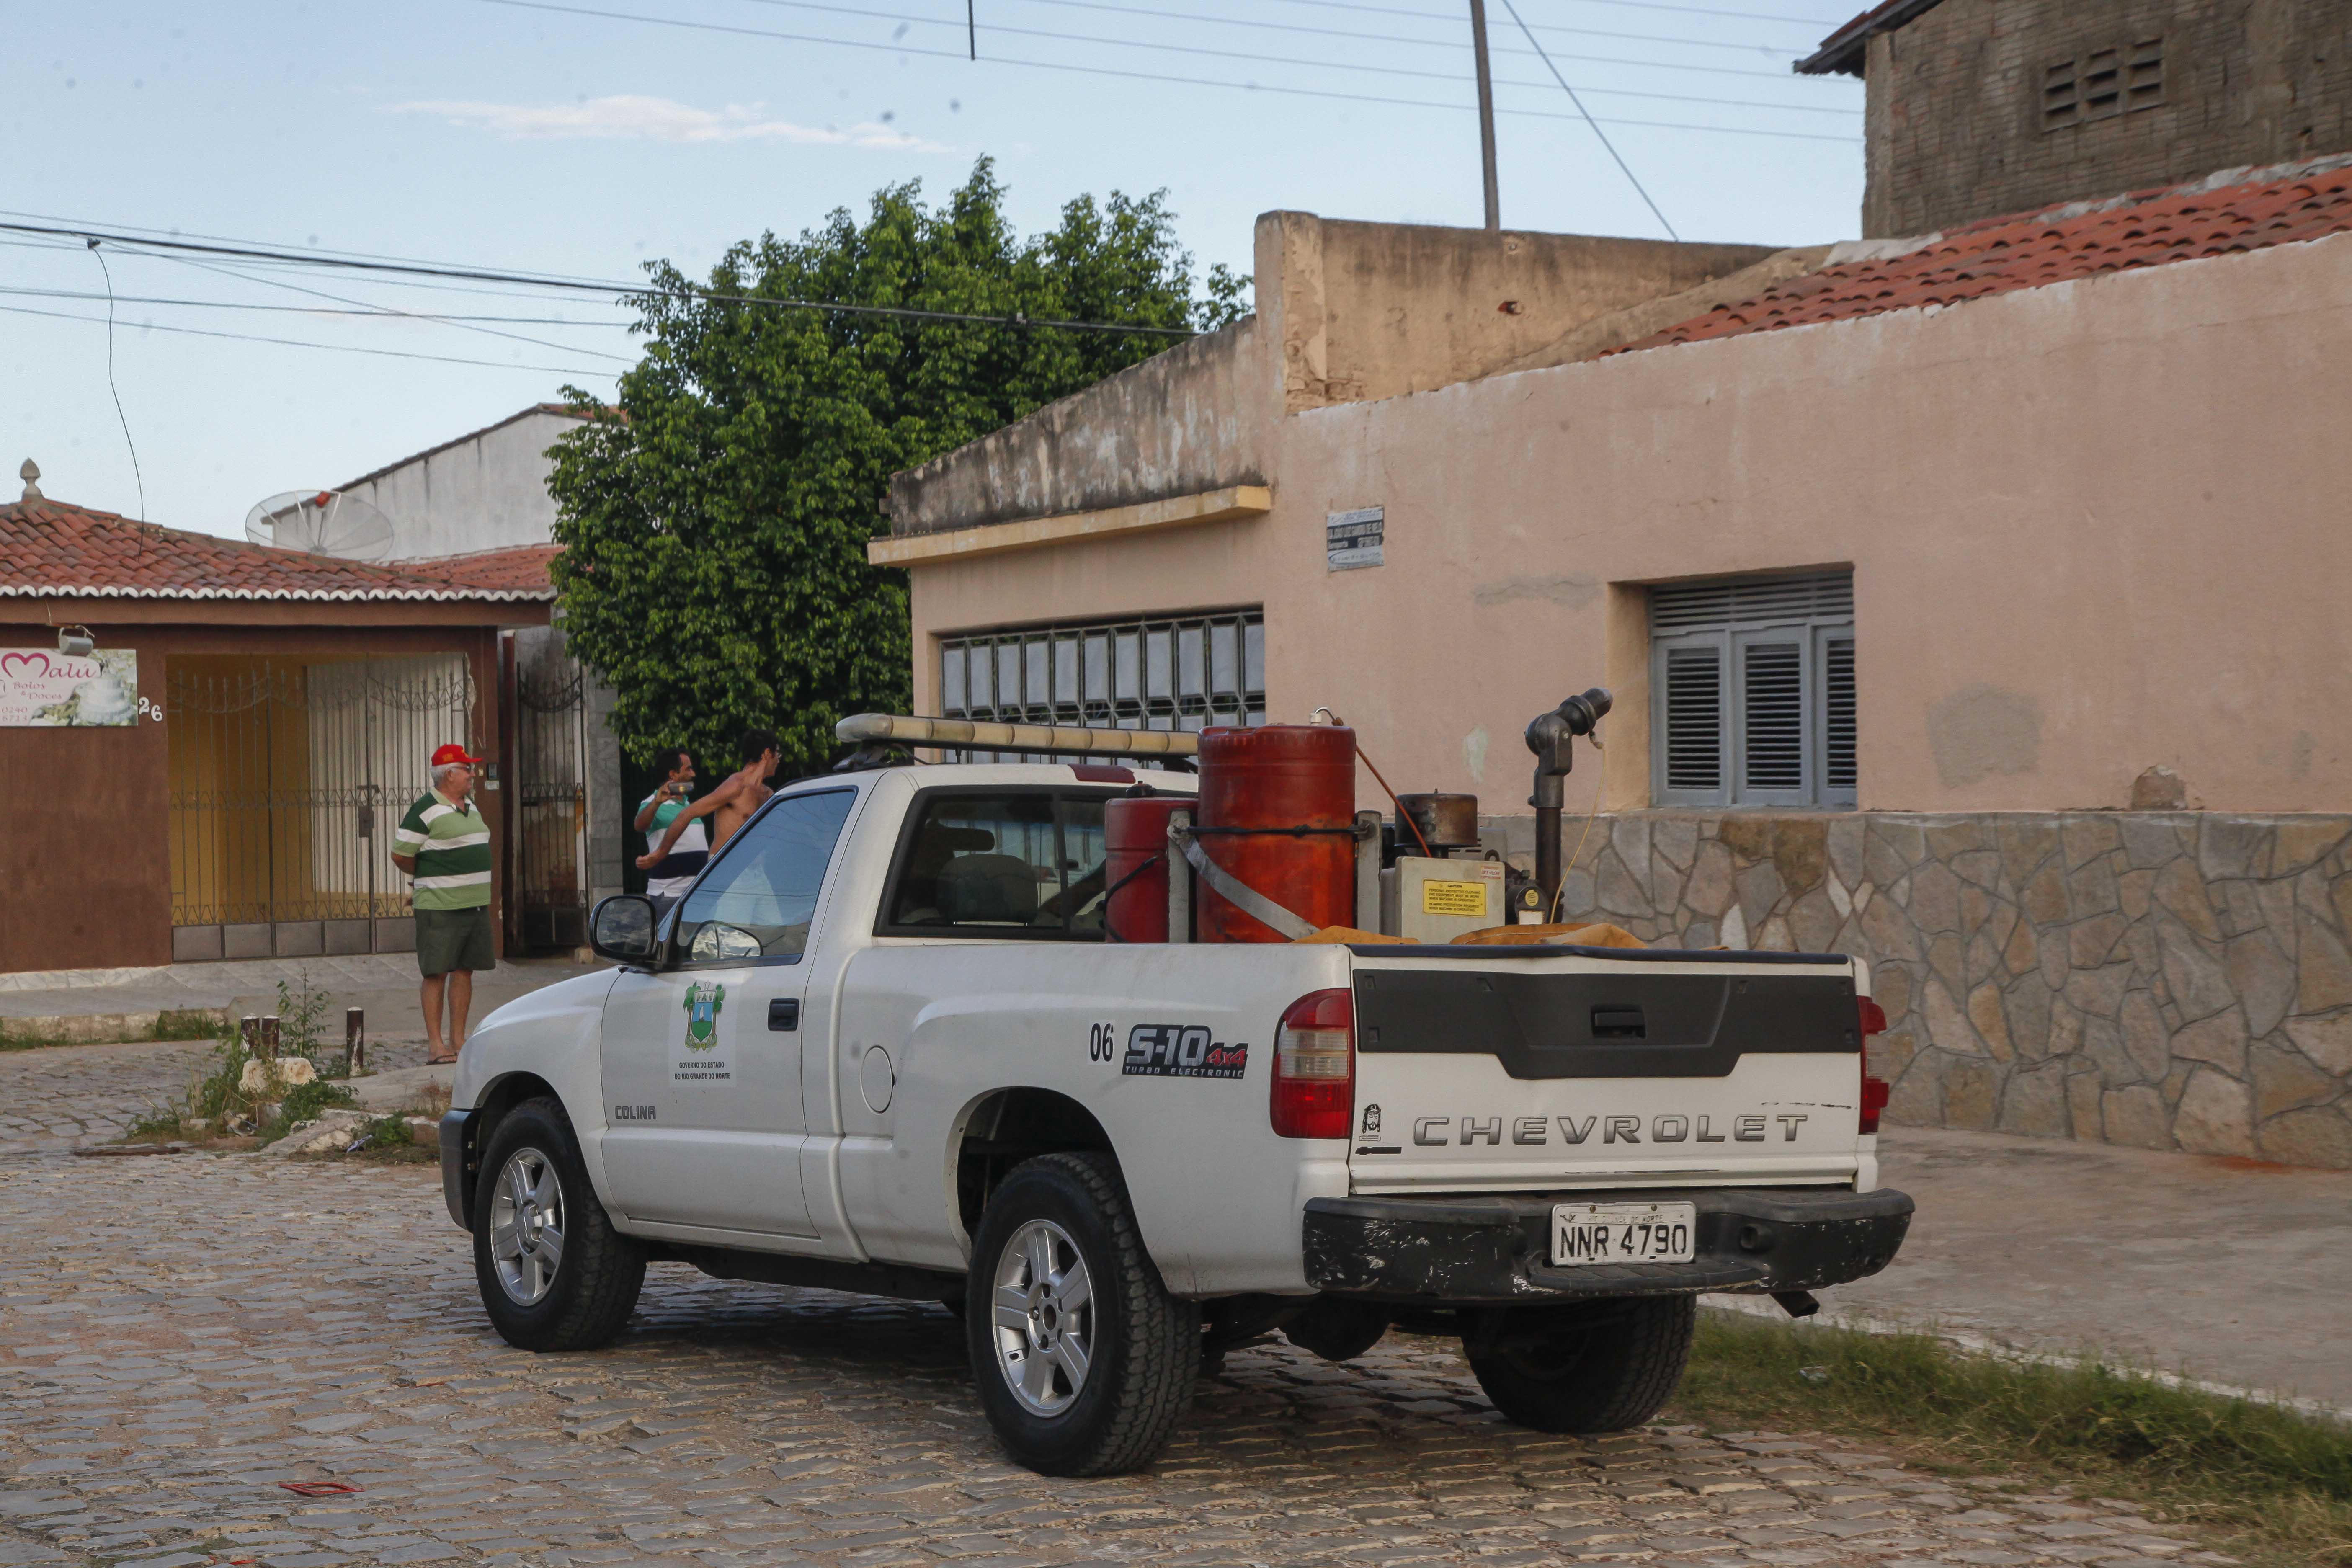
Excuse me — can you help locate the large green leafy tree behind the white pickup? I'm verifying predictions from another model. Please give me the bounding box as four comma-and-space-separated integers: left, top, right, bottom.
548, 160, 1246, 771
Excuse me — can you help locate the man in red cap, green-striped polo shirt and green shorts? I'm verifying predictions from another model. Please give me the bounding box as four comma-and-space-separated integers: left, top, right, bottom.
393, 745, 499, 1063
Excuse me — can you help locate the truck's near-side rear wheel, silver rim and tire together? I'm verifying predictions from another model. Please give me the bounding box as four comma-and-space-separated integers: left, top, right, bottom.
965, 1154, 1199, 1476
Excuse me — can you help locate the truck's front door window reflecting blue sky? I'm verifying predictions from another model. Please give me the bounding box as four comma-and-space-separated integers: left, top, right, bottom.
675, 790, 856, 964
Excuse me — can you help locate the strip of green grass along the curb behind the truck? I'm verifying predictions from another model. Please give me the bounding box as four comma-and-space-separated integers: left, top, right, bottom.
1672, 1312, 2352, 1568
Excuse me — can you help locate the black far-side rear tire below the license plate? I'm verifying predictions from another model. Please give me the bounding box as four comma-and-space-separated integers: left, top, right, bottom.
1463, 1295, 1698, 1434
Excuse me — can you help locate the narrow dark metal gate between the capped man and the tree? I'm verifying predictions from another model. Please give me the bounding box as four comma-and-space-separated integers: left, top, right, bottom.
508, 660, 588, 947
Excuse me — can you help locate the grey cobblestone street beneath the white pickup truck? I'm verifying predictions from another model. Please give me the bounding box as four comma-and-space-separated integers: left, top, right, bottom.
0, 1157, 2211, 1568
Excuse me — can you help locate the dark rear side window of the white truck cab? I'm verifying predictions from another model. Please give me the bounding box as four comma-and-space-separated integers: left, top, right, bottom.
885, 790, 1103, 938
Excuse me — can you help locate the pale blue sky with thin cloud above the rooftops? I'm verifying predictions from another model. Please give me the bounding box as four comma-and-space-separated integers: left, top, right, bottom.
0, 0, 1863, 534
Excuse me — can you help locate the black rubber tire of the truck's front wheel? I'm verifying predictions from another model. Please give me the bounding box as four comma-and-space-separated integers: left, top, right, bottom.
473, 1096, 645, 1352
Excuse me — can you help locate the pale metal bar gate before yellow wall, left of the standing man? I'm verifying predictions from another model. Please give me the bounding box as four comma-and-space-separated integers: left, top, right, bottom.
165, 653, 473, 959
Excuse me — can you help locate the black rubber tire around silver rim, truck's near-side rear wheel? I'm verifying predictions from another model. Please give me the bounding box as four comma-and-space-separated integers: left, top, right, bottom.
965, 1154, 1202, 1476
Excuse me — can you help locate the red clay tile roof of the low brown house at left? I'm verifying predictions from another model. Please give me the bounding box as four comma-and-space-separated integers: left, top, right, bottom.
0, 501, 555, 602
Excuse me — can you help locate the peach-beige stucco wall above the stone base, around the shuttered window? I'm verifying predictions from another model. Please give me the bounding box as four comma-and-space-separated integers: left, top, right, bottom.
915, 237, 2352, 811
